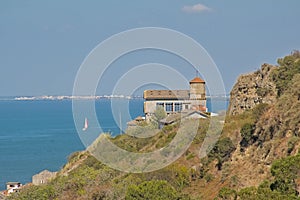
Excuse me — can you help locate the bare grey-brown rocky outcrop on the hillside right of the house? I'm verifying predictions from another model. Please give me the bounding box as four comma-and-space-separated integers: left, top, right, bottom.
228, 64, 277, 115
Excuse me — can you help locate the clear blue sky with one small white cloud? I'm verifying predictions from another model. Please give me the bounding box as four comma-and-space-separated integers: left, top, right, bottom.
0, 0, 300, 96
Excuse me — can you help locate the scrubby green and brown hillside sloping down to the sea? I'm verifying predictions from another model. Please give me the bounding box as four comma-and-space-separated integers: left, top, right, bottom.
9, 51, 300, 200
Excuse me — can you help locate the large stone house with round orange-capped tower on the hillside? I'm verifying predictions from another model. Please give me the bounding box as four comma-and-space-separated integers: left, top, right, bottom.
144, 77, 207, 121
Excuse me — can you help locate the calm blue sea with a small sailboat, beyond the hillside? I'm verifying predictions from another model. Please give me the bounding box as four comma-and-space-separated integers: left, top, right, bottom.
0, 98, 228, 190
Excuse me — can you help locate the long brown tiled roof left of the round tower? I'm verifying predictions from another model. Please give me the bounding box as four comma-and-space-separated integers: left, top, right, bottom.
144, 90, 190, 100
